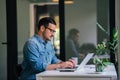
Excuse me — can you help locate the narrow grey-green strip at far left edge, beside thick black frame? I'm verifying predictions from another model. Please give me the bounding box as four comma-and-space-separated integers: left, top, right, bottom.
0, 0, 7, 80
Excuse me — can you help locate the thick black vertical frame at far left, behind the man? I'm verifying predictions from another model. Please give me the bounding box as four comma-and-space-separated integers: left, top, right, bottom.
6, 0, 18, 80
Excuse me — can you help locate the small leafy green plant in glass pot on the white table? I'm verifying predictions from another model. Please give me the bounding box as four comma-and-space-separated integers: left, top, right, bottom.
93, 42, 110, 72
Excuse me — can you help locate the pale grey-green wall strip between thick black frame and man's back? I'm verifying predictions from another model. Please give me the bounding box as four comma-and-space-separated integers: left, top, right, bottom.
17, 0, 30, 63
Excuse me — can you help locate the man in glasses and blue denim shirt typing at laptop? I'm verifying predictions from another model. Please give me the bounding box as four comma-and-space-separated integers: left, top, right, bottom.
20, 17, 75, 80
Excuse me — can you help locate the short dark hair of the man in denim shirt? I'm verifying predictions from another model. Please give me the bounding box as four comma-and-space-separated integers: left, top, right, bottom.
37, 17, 56, 30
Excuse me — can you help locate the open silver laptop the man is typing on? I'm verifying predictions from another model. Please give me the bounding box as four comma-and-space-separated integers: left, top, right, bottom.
57, 53, 94, 72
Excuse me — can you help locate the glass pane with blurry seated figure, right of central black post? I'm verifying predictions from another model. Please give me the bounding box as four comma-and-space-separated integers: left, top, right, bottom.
64, 0, 109, 63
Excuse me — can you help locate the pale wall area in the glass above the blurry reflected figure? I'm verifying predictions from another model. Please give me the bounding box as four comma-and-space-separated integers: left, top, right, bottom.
65, 0, 97, 45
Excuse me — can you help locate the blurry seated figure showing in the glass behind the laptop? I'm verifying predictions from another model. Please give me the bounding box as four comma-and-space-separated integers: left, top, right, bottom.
66, 28, 83, 59
